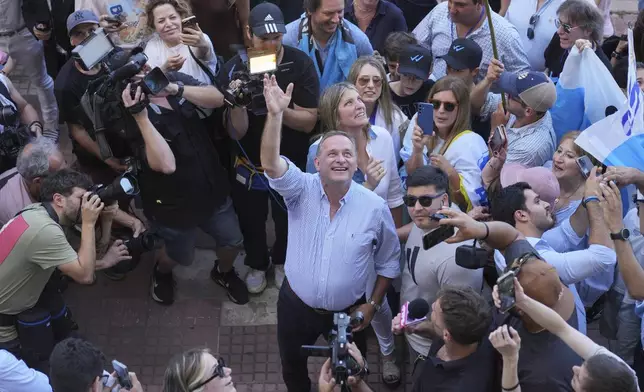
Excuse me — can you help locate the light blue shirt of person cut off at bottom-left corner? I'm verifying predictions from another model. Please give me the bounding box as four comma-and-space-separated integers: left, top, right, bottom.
0, 350, 51, 392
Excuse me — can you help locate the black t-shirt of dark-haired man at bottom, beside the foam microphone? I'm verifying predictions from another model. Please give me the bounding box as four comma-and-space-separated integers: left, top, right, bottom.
412, 337, 504, 392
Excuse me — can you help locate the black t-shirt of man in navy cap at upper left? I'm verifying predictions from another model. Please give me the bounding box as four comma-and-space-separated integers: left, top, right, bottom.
54, 59, 130, 167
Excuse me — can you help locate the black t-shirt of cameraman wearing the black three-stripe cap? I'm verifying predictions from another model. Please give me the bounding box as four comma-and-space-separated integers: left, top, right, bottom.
218, 46, 320, 169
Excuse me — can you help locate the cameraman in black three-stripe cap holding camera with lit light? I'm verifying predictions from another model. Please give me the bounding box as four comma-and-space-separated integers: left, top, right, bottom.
219, 3, 319, 293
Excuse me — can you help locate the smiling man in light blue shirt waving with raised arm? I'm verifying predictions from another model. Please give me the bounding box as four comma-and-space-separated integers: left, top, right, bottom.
260, 76, 400, 392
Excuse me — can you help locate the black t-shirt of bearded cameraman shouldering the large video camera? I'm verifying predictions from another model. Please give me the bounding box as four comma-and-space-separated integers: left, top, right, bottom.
139, 72, 229, 228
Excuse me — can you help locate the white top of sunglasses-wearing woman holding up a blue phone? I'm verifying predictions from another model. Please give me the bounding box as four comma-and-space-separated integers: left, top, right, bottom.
400, 114, 489, 207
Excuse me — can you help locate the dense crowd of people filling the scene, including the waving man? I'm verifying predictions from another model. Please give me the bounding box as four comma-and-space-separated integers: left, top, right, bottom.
0, 0, 644, 392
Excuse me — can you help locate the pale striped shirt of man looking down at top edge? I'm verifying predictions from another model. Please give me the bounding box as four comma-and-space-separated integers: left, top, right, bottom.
413, 1, 530, 83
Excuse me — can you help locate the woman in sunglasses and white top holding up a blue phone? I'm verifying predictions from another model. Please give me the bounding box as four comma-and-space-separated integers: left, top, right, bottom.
400, 76, 489, 211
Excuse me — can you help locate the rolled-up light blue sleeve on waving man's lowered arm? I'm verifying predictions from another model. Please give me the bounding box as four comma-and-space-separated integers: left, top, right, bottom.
374, 207, 400, 279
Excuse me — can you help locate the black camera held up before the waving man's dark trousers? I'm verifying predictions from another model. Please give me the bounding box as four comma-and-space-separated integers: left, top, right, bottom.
302, 312, 364, 391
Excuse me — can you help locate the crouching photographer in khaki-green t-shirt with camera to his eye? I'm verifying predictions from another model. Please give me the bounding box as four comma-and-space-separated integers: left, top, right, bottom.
0, 169, 125, 367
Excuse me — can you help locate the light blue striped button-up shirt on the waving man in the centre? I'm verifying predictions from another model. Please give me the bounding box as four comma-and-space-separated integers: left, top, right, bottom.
267, 158, 400, 311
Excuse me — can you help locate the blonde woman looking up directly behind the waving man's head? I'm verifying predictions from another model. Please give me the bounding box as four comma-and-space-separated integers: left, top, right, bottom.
306, 82, 403, 385
